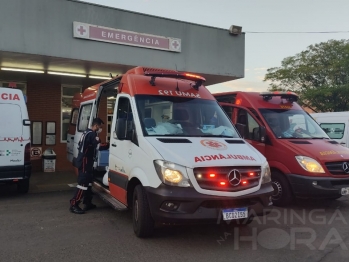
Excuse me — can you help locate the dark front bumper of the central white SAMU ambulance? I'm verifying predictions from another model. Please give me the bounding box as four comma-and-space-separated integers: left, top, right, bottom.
145, 183, 273, 224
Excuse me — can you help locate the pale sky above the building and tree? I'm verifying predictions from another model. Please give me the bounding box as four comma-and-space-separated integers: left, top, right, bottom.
79, 0, 349, 93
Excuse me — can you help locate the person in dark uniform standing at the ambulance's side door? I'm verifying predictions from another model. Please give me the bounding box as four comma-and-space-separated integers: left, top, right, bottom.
69, 118, 104, 214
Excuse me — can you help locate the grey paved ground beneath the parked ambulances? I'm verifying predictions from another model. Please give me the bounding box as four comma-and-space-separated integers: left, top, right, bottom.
0, 173, 349, 262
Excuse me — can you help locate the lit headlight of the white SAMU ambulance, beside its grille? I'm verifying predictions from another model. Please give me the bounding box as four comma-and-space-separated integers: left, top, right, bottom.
154, 160, 191, 187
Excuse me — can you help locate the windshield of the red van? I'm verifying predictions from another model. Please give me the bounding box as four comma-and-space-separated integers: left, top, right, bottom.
259, 109, 329, 139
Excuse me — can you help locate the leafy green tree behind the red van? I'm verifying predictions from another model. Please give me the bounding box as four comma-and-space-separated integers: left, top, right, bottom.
264, 40, 349, 112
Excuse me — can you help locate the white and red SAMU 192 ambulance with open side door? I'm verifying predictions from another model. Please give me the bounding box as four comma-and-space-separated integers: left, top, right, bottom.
69, 67, 273, 237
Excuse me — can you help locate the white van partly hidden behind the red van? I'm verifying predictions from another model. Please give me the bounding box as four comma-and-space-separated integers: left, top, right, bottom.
310, 111, 349, 147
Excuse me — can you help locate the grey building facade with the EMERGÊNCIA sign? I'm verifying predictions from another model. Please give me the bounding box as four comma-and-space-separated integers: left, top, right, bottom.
0, 0, 245, 171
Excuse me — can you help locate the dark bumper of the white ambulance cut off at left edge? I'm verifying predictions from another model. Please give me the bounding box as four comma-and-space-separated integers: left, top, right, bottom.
0, 163, 32, 183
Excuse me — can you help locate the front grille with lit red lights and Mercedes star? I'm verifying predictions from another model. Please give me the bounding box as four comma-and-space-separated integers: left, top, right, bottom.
194, 166, 261, 192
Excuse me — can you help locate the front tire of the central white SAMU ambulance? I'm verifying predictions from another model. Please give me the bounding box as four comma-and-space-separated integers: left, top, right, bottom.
132, 185, 155, 238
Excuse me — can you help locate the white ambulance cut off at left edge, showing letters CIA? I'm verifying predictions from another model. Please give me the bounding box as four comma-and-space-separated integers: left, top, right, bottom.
0, 87, 31, 193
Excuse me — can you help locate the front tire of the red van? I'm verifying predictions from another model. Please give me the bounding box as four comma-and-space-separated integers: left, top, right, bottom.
271, 171, 294, 206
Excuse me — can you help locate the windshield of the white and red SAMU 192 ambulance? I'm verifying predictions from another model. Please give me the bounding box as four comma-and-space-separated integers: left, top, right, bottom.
135, 95, 239, 138
